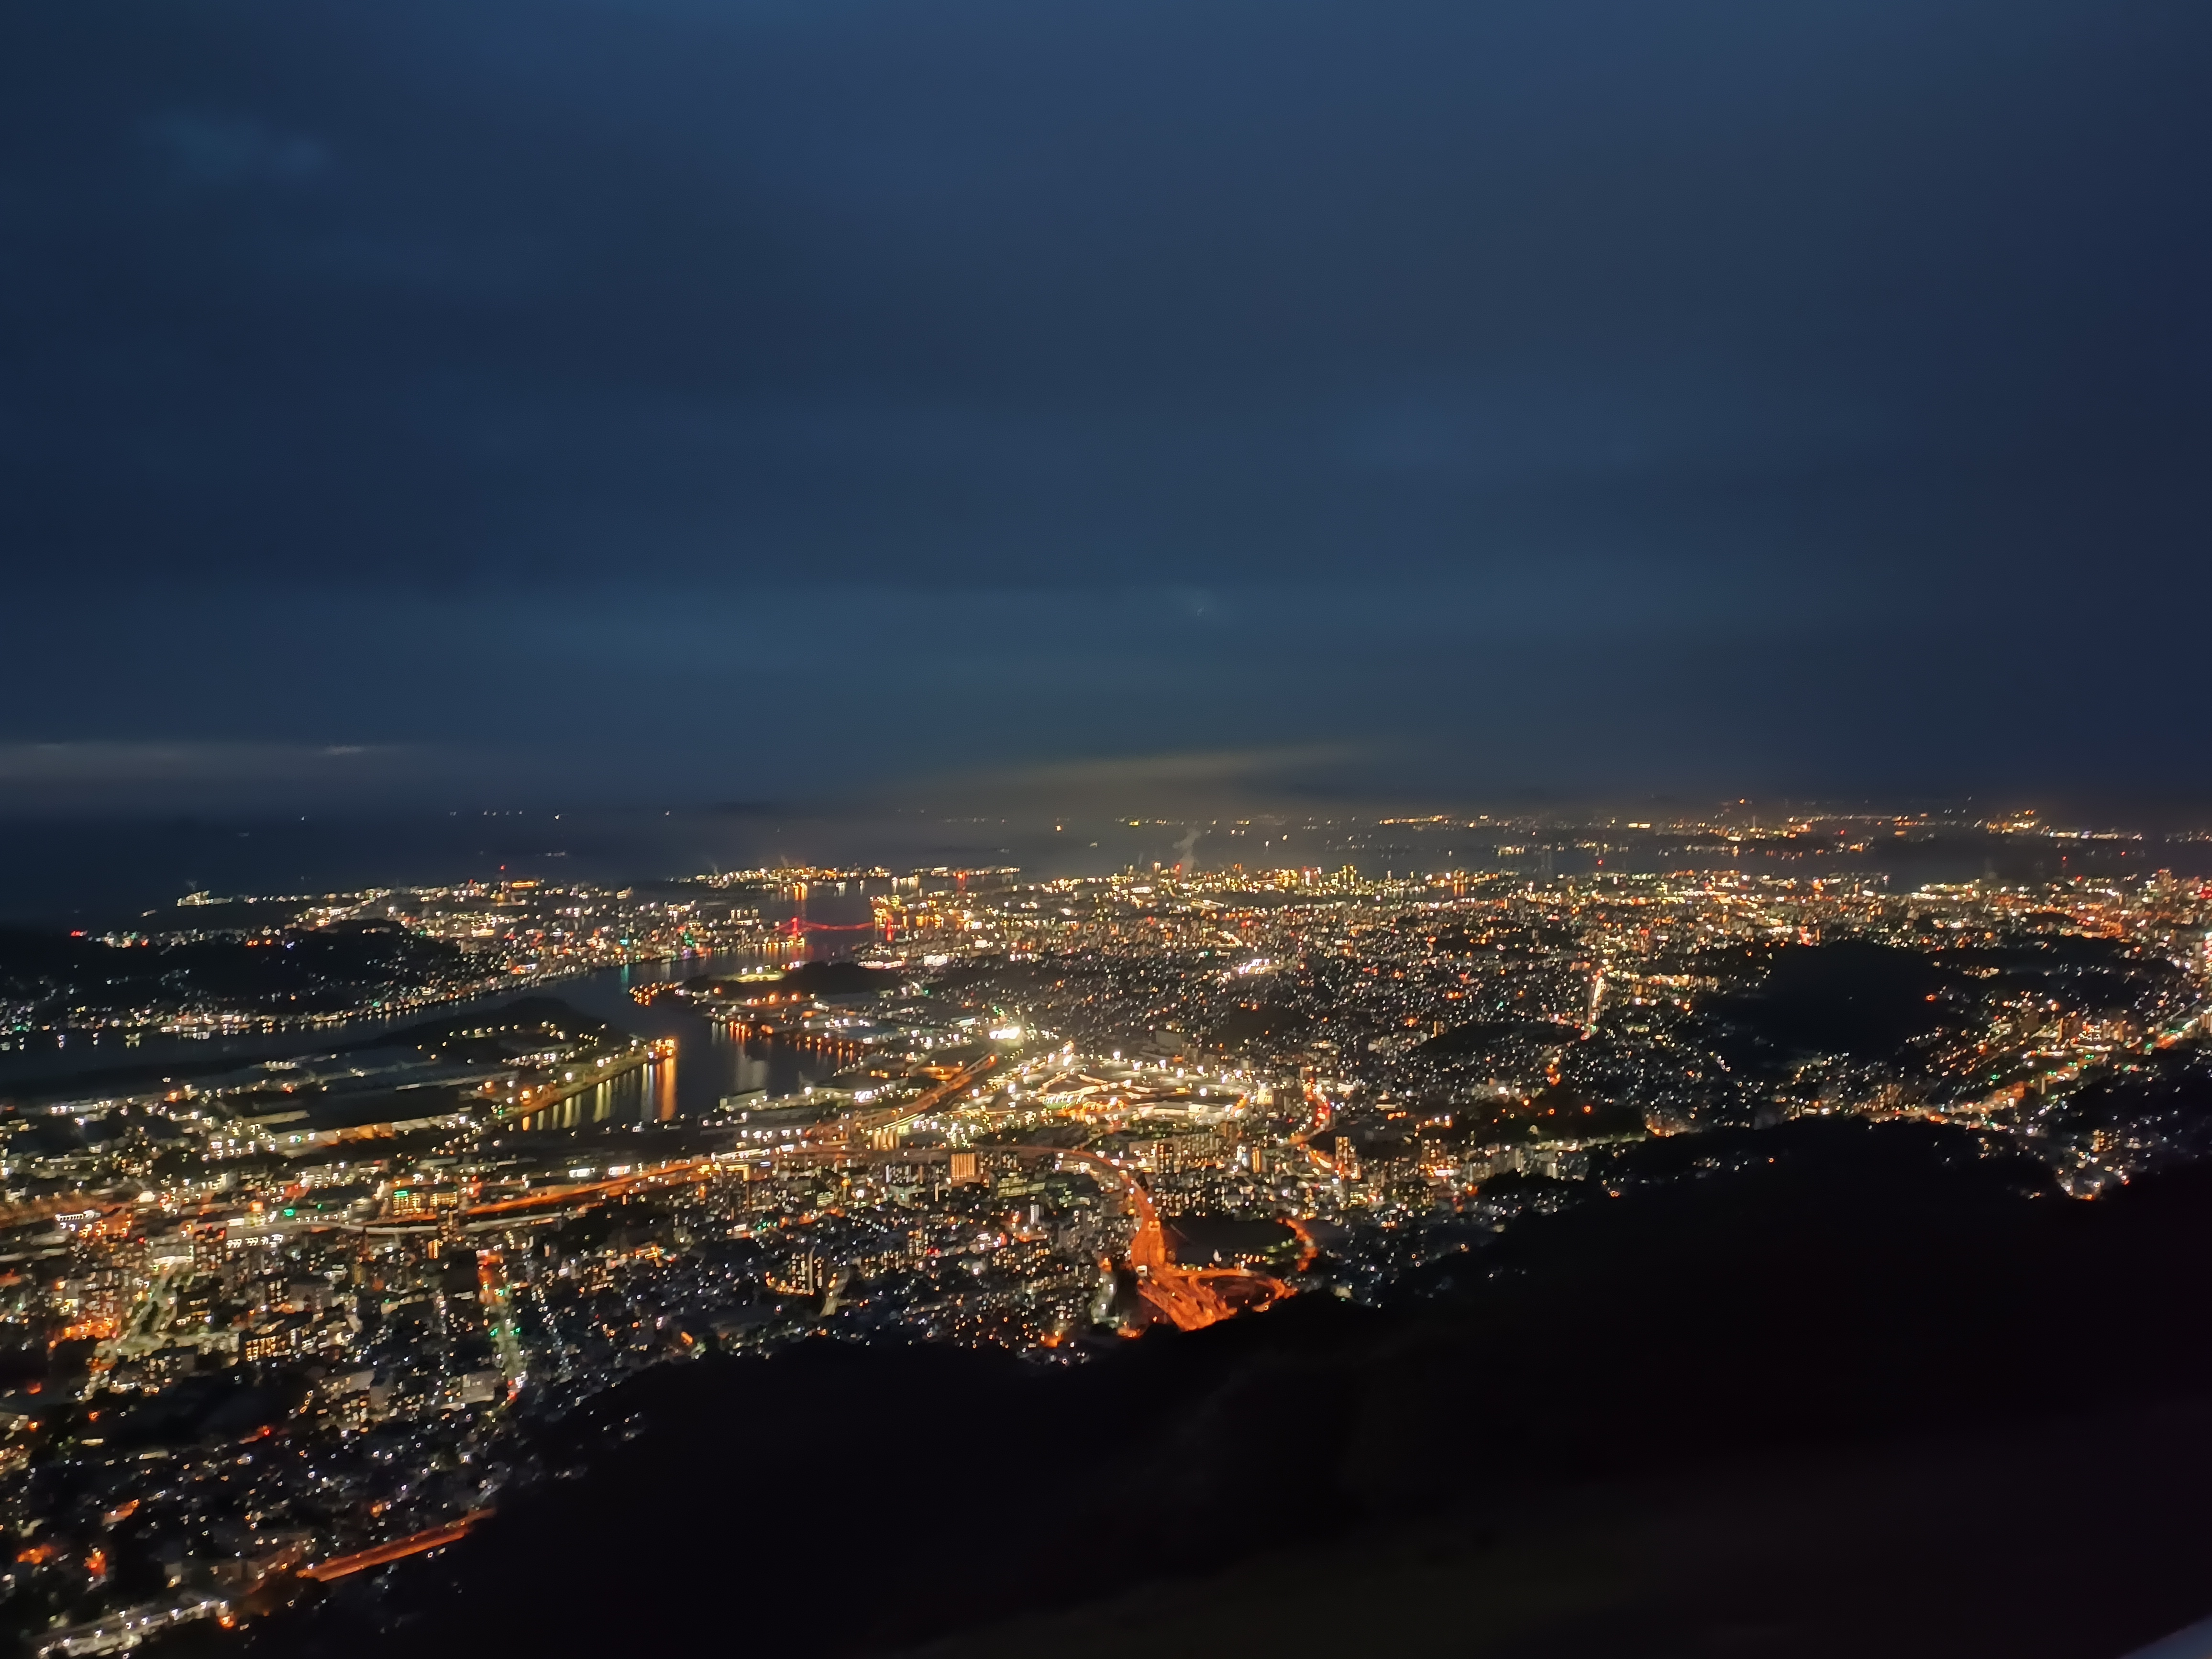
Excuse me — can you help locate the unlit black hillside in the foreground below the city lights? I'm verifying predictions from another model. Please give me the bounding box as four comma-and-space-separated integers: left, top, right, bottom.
248, 1124, 2212, 1659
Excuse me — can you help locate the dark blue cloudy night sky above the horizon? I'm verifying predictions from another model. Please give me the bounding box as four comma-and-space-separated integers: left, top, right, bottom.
0, 0, 2212, 812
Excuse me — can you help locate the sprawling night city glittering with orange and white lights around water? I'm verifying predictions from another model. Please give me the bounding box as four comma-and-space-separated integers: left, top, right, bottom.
0, 823, 2212, 1659
